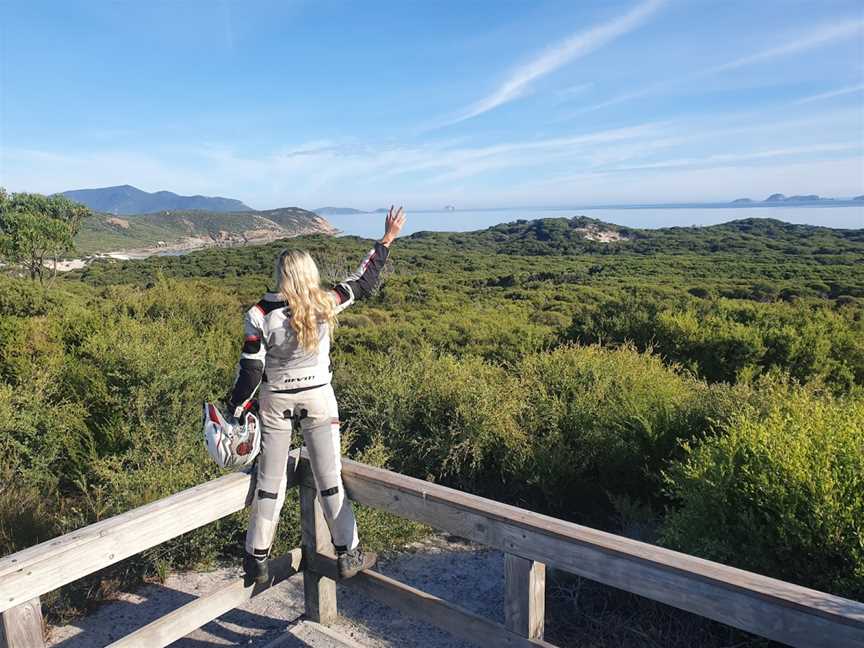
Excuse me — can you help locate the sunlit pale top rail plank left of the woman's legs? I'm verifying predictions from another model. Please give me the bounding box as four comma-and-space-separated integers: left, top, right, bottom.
0, 452, 296, 612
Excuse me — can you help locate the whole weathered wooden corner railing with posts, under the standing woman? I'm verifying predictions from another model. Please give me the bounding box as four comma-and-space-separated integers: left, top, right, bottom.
0, 452, 864, 648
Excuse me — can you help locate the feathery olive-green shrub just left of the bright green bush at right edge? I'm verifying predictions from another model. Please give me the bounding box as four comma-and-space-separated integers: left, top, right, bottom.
519, 345, 731, 522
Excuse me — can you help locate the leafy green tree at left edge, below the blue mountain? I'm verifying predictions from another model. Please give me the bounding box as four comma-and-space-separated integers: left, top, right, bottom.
0, 188, 92, 283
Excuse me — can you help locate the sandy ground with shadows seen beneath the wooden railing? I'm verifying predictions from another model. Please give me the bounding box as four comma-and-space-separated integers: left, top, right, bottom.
48, 536, 504, 648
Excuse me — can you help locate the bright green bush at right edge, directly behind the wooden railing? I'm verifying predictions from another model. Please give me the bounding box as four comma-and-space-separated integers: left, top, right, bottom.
661, 384, 864, 599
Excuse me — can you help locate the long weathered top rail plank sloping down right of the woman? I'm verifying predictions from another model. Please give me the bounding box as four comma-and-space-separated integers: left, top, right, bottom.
294, 459, 864, 648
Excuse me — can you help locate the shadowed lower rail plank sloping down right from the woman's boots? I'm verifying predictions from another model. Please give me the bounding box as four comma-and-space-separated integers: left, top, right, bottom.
304, 554, 554, 648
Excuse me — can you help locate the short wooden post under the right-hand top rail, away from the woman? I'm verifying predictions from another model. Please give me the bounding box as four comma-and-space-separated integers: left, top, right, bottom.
504, 553, 546, 639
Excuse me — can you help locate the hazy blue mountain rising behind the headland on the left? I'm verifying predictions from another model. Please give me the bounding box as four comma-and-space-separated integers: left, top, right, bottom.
62, 185, 252, 216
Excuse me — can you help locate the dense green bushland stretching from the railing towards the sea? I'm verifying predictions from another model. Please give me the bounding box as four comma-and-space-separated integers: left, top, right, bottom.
0, 215, 864, 620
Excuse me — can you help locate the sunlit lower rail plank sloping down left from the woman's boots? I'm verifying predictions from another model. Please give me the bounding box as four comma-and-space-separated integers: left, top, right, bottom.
108, 548, 303, 648
